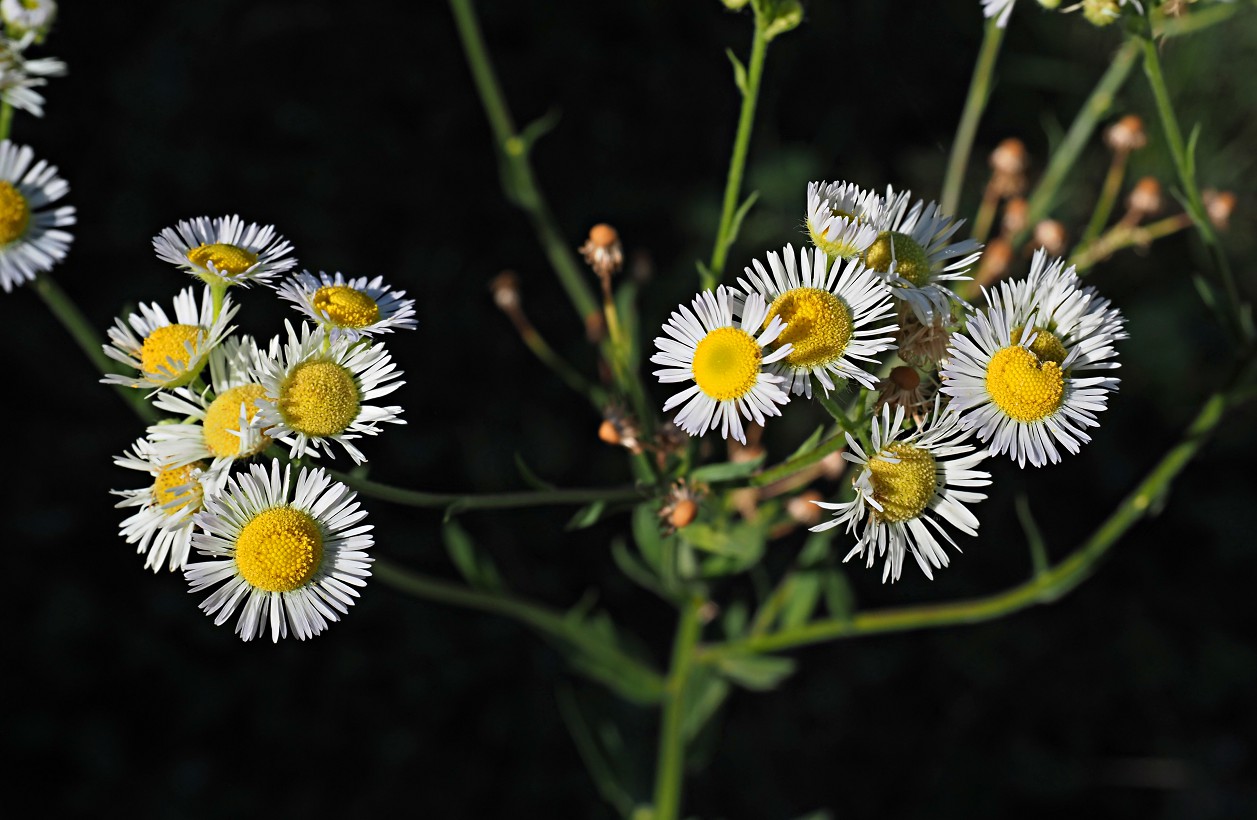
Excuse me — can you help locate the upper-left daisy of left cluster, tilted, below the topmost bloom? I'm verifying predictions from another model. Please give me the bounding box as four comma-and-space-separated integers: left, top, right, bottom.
101, 288, 239, 390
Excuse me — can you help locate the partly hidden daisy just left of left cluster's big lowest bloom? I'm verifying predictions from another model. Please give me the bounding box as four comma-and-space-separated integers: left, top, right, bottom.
112, 439, 206, 572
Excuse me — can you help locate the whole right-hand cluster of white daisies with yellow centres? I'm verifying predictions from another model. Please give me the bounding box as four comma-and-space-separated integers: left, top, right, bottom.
651, 182, 1126, 580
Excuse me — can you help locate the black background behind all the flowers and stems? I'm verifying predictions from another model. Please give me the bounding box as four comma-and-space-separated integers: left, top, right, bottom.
9, 0, 1257, 817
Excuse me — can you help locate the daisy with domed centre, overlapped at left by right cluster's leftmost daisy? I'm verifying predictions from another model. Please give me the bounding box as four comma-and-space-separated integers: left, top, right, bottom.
738, 245, 895, 399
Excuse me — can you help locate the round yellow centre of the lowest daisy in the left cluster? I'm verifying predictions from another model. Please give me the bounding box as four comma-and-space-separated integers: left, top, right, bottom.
236, 507, 323, 592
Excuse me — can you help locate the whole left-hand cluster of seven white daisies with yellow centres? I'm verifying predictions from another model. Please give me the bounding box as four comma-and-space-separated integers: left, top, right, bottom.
102, 216, 416, 640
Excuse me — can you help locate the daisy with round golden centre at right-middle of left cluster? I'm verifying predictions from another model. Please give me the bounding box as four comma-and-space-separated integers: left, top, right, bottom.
259, 321, 406, 464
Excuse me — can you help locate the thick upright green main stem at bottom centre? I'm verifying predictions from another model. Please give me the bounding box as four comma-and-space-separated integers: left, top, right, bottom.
651, 597, 703, 820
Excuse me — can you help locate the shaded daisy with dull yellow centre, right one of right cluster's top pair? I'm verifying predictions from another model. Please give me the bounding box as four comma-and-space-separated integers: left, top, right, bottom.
864, 189, 982, 326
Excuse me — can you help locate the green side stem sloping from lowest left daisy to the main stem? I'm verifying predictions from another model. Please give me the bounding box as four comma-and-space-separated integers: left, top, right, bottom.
371, 557, 665, 694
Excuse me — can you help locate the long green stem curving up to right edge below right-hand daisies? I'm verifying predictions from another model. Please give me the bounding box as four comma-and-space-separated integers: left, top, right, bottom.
700, 361, 1253, 663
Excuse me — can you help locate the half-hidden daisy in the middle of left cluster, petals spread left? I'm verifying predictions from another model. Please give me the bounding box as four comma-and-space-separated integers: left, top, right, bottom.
148, 336, 272, 492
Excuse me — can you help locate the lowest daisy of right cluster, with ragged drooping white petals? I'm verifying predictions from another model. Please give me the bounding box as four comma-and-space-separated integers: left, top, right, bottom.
812, 400, 991, 582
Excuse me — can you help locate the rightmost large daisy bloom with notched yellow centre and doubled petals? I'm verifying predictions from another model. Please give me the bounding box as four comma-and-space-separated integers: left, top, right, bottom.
939, 254, 1125, 467
